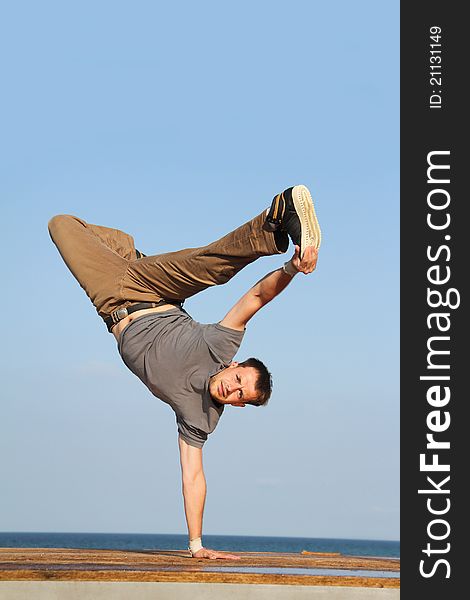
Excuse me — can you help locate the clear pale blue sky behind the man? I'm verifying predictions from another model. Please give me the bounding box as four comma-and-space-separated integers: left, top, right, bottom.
0, 0, 399, 539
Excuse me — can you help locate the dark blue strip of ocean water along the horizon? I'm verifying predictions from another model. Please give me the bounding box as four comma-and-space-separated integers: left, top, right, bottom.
0, 532, 400, 558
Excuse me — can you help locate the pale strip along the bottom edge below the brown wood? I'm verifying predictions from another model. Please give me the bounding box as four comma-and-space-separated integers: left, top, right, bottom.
0, 581, 400, 600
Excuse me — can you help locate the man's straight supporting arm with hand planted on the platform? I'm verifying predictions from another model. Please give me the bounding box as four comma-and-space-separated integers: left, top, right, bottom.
178, 436, 240, 559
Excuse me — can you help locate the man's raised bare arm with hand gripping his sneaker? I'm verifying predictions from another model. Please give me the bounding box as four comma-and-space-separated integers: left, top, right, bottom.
220, 246, 318, 331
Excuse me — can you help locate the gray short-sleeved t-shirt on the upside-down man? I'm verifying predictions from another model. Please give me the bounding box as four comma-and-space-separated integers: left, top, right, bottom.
118, 308, 244, 448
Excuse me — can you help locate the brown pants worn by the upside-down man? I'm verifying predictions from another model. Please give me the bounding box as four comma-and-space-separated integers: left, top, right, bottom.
49, 212, 289, 330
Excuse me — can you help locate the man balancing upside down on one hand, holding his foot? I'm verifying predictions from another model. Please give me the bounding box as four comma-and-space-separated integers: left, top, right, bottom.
49, 185, 321, 559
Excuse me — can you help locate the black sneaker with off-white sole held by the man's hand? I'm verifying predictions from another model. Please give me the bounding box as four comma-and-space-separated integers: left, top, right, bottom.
265, 185, 321, 257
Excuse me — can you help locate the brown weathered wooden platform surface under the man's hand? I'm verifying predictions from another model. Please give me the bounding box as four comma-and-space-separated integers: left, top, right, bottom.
0, 548, 400, 600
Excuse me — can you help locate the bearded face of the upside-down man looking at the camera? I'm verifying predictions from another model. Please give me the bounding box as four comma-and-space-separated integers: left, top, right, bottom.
209, 362, 258, 406
